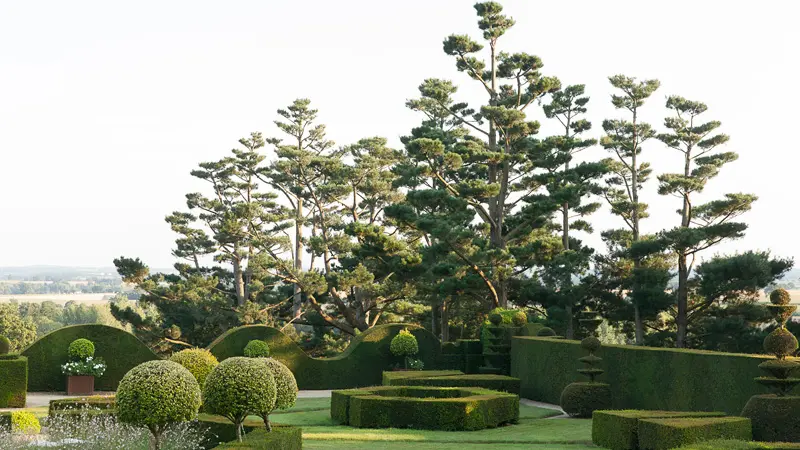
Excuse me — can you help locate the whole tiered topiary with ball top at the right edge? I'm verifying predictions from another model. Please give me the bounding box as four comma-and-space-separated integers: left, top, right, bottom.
742, 289, 800, 442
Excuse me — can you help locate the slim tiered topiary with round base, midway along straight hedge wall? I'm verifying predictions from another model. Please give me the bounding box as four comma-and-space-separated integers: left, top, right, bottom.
561, 311, 611, 417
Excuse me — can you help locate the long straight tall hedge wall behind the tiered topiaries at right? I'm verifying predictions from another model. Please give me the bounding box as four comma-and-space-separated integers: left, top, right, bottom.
511, 336, 800, 415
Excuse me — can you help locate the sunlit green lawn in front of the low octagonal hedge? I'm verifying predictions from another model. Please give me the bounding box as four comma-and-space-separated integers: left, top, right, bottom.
271, 398, 597, 450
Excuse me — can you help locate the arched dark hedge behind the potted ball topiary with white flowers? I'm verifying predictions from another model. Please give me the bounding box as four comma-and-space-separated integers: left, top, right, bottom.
22, 324, 158, 392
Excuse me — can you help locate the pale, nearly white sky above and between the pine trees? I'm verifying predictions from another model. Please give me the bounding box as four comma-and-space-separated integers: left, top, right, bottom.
0, 0, 800, 267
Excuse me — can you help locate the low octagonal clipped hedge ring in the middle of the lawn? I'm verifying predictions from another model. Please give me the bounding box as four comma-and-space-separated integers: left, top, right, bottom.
331, 386, 519, 430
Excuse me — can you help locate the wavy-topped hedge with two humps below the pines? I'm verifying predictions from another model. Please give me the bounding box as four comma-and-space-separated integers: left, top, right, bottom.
208, 324, 441, 389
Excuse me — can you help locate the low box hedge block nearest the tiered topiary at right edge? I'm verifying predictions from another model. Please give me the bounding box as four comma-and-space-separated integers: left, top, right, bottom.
639, 417, 753, 450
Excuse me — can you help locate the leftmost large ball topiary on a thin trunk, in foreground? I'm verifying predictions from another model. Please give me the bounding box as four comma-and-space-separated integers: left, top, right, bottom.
116, 360, 201, 449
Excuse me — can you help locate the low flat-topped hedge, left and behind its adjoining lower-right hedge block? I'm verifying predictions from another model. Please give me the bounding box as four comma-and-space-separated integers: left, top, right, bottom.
592, 409, 725, 450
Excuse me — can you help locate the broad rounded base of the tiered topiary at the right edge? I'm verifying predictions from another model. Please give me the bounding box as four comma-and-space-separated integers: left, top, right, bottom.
741, 395, 800, 442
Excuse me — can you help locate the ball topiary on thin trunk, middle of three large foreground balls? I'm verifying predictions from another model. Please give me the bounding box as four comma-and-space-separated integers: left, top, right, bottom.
203, 356, 277, 441
